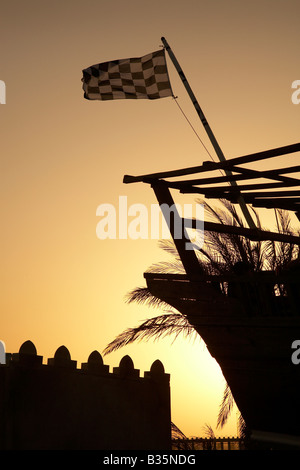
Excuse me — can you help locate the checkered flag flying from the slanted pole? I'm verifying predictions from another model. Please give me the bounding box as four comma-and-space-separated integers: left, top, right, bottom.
82, 49, 173, 100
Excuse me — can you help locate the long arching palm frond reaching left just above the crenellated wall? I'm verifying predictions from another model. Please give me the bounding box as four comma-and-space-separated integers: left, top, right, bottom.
103, 312, 200, 355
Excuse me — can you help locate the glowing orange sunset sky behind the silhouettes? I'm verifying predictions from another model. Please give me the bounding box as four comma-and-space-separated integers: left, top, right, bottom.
0, 0, 300, 436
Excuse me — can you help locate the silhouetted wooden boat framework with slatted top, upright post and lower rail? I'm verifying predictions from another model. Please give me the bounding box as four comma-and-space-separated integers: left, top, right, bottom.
124, 143, 300, 255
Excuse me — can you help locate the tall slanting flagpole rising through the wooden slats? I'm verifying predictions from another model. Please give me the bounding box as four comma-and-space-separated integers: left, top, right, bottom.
161, 37, 256, 228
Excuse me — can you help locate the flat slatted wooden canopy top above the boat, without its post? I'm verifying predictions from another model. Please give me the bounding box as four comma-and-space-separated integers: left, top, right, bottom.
123, 143, 300, 220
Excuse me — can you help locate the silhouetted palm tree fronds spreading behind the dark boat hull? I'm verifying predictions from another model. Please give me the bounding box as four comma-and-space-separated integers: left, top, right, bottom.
104, 200, 300, 433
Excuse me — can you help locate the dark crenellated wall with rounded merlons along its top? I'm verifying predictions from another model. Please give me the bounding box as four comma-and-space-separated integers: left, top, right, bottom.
0, 341, 171, 450
